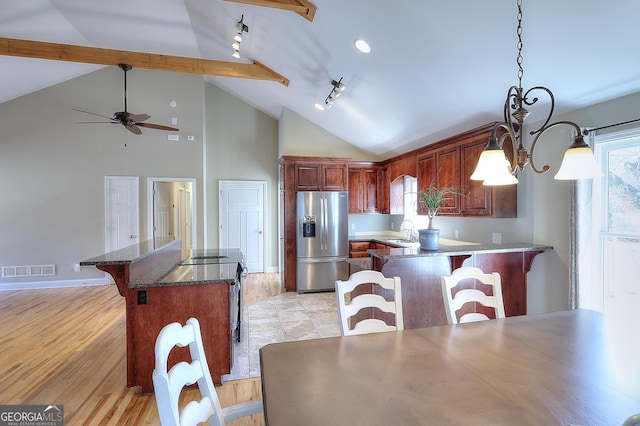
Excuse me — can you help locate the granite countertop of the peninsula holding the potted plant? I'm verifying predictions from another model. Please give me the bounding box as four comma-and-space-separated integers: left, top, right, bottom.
367, 239, 553, 259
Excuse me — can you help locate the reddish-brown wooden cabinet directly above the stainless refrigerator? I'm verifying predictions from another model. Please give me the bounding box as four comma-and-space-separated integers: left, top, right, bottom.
283, 156, 349, 191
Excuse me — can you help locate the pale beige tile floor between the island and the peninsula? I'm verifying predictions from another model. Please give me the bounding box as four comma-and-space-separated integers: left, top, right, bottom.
222, 292, 340, 381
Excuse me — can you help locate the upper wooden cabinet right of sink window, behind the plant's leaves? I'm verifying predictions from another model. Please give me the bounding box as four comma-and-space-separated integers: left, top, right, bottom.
417, 144, 461, 216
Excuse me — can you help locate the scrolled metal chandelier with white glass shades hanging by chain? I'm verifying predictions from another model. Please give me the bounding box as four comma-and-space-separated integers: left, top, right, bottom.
471, 0, 602, 185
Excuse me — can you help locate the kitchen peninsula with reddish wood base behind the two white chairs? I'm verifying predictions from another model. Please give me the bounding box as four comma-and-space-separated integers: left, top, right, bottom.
348, 240, 552, 329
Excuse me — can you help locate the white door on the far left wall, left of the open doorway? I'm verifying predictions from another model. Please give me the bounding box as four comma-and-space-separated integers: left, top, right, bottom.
105, 176, 140, 253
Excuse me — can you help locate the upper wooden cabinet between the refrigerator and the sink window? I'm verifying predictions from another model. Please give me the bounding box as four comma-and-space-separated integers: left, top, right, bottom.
349, 163, 380, 214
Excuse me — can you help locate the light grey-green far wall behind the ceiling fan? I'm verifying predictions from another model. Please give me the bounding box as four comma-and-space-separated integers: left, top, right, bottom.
0, 67, 204, 284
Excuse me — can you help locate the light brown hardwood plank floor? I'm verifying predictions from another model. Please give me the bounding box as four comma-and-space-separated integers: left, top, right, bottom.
0, 274, 281, 425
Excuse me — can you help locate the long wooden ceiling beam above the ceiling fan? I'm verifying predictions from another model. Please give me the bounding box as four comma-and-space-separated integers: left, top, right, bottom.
0, 37, 289, 86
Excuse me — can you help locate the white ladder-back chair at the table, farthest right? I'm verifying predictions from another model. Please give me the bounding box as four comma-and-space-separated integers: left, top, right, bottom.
441, 266, 505, 324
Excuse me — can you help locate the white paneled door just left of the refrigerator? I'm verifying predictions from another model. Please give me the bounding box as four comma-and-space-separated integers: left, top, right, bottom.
219, 180, 266, 273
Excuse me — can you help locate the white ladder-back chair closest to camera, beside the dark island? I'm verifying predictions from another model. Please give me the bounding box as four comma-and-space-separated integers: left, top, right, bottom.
153, 318, 262, 426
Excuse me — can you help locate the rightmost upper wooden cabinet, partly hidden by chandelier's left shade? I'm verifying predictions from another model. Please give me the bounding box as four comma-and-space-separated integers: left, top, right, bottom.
460, 126, 518, 217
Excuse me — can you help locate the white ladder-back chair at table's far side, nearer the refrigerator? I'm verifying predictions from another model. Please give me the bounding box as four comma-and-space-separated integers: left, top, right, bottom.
336, 270, 404, 336
